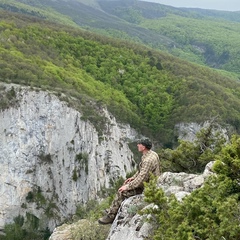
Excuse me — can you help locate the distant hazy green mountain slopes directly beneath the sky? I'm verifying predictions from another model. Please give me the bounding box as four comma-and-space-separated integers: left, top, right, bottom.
0, 0, 240, 78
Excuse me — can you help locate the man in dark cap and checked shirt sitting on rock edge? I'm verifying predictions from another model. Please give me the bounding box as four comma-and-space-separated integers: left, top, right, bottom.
98, 139, 160, 224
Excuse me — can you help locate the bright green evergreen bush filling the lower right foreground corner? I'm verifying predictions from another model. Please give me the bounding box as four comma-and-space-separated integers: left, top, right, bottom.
144, 136, 240, 240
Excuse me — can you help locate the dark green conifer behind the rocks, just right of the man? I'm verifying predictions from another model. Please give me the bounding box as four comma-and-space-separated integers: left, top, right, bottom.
159, 119, 226, 173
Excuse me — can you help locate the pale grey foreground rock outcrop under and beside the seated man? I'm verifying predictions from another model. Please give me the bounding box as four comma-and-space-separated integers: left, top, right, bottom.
50, 162, 213, 240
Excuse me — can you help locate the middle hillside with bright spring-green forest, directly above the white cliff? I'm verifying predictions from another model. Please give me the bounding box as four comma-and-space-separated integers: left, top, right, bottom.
0, 11, 240, 144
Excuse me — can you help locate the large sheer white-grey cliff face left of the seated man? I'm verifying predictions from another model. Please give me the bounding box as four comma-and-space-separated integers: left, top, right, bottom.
0, 86, 136, 230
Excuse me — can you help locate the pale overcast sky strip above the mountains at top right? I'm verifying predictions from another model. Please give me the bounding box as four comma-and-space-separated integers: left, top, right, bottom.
143, 0, 240, 11
